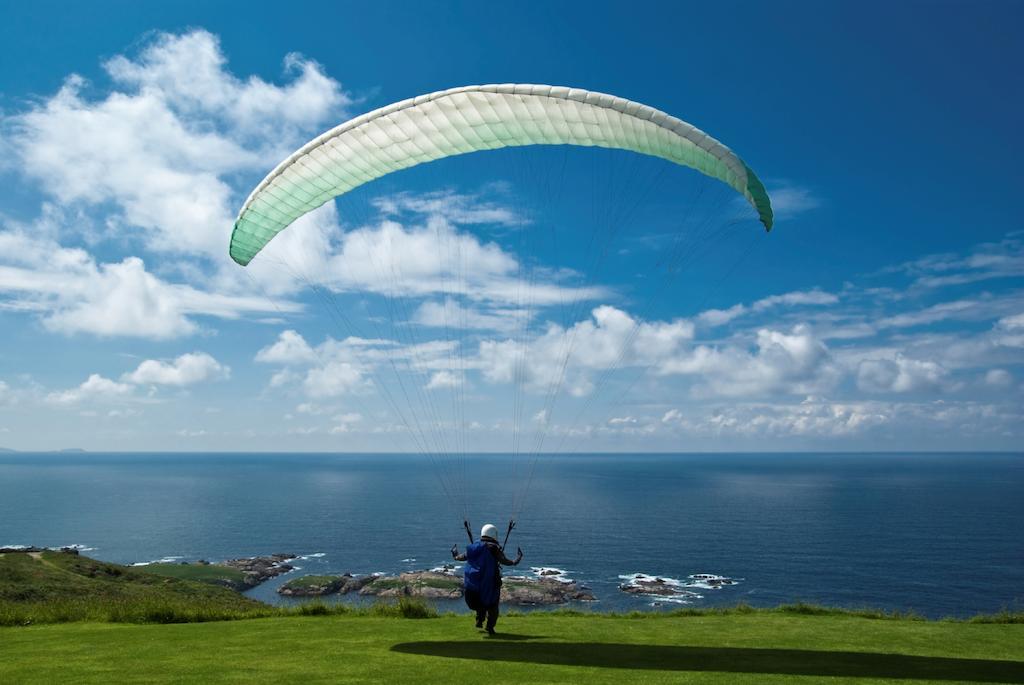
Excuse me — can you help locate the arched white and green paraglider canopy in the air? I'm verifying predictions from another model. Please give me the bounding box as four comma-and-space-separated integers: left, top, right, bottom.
230, 84, 772, 265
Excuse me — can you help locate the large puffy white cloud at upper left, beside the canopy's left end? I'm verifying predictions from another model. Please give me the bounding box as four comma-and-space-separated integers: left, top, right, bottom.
6, 31, 351, 257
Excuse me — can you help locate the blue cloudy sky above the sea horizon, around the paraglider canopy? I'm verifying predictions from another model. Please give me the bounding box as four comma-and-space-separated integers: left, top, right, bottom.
0, 2, 1024, 453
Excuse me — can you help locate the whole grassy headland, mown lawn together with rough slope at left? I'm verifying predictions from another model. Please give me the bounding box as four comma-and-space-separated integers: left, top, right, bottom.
0, 551, 1024, 684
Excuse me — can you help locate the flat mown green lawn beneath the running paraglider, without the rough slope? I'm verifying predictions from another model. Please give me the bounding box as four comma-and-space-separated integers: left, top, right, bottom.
0, 612, 1024, 683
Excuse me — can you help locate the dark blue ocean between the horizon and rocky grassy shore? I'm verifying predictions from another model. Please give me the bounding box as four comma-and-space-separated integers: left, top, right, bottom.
0, 453, 1024, 617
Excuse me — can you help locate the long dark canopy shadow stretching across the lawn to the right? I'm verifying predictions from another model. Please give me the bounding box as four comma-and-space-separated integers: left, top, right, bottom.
391, 640, 1024, 683
